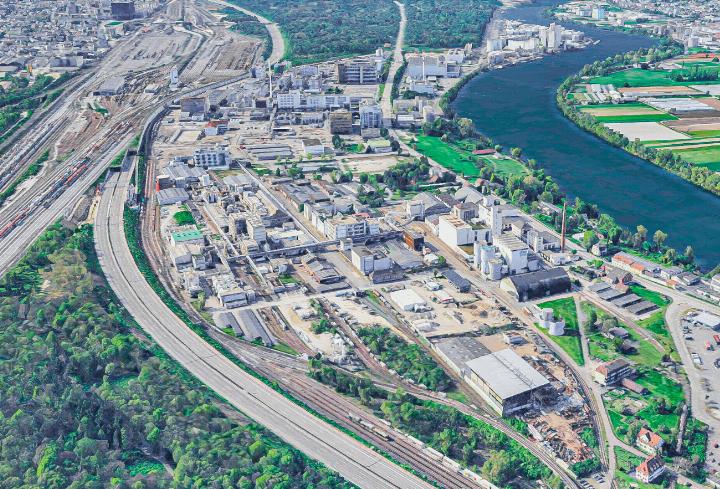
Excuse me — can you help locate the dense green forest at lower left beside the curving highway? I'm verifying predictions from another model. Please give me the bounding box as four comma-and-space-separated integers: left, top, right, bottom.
0, 225, 350, 489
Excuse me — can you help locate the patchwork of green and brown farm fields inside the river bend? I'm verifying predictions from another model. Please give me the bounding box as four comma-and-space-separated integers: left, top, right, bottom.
557, 51, 720, 196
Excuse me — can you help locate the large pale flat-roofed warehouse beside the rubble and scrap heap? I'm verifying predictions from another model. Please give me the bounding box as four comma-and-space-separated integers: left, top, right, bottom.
467, 348, 550, 416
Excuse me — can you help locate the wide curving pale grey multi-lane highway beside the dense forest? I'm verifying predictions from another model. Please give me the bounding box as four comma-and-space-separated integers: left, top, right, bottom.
95, 172, 431, 489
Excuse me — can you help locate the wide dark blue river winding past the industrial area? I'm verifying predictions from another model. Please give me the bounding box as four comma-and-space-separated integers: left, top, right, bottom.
453, 0, 720, 268
